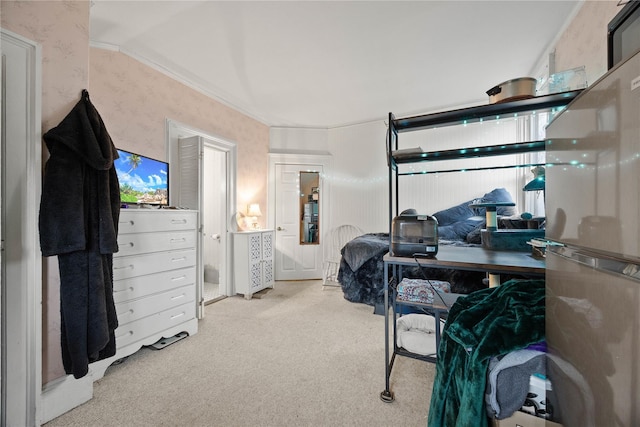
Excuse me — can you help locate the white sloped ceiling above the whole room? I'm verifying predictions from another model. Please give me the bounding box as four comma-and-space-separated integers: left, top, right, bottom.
90, 0, 581, 128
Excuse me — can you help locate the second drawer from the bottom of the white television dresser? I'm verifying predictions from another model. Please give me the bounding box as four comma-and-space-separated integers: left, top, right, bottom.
116, 286, 196, 326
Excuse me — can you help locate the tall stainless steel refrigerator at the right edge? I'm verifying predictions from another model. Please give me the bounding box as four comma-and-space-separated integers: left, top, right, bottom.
545, 49, 640, 426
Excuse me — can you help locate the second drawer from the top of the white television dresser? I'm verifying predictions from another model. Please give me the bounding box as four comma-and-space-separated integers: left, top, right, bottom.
113, 230, 196, 258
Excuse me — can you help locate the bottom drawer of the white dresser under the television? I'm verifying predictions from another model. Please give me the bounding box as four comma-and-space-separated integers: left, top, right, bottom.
115, 302, 196, 349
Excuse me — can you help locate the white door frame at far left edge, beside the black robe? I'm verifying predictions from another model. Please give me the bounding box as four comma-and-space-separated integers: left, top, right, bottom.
0, 28, 42, 426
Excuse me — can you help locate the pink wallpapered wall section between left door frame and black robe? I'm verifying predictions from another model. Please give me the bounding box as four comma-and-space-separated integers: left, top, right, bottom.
0, 0, 89, 383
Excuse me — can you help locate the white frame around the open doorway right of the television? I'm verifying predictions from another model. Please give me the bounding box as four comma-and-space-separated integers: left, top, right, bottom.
165, 119, 238, 318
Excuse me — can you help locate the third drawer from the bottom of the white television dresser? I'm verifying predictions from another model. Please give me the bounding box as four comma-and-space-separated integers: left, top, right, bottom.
113, 267, 196, 304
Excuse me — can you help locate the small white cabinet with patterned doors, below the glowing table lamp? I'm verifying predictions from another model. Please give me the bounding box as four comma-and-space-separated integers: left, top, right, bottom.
233, 230, 275, 299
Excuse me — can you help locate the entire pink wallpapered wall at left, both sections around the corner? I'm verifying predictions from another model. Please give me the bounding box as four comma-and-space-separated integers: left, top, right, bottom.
1, 0, 269, 384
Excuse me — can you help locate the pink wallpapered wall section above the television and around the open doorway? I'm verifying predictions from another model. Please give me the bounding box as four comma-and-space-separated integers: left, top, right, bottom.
89, 48, 269, 209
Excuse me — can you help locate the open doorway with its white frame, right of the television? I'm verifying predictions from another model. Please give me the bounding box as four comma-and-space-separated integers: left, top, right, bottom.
167, 120, 237, 318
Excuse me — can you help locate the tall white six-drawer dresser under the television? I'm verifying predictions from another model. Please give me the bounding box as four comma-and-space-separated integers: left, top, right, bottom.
113, 209, 198, 358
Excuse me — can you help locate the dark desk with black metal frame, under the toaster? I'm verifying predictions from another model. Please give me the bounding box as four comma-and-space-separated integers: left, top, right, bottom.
380, 246, 545, 402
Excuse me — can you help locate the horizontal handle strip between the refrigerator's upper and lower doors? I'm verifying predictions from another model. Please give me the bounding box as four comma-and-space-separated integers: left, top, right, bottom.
547, 245, 640, 281
